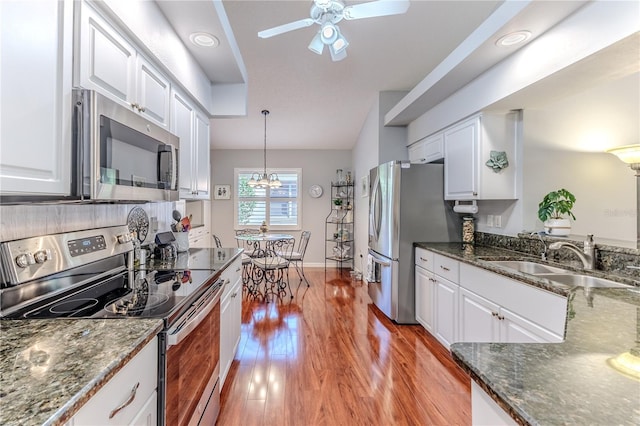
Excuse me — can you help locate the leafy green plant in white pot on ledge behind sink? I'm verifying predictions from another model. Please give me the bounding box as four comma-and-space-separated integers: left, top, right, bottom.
538, 188, 576, 237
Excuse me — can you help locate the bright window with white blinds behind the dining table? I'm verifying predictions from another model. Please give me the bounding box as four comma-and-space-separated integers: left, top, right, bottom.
234, 169, 302, 230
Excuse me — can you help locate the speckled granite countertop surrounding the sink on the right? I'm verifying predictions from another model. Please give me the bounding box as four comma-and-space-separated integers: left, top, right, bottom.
415, 243, 640, 425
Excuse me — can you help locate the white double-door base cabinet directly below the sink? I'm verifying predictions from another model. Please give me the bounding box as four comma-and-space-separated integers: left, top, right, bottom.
459, 263, 567, 343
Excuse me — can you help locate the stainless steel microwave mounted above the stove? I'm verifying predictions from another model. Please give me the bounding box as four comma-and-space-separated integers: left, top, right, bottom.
72, 89, 180, 202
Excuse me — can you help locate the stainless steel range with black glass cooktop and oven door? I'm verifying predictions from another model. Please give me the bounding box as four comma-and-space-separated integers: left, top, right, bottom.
0, 226, 239, 425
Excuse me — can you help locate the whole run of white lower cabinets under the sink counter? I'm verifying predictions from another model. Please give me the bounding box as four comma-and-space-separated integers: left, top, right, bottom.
415, 248, 567, 348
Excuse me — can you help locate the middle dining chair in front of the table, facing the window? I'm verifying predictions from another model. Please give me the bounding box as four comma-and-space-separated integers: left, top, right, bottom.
251, 238, 296, 302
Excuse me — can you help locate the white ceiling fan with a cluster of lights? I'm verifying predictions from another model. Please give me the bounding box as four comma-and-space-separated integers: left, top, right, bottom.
258, 0, 409, 61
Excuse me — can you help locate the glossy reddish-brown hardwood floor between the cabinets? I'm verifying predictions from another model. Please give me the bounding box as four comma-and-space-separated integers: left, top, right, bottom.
217, 268, 471, 426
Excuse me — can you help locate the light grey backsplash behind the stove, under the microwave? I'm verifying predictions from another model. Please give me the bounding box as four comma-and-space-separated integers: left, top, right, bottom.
0, 201, 184, 243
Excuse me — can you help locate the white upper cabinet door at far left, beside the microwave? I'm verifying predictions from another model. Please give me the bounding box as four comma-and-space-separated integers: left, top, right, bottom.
0, 0, 74, 196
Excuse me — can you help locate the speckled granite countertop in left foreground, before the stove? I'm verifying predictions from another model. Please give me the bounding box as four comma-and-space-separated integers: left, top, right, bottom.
0, 318, 163, 426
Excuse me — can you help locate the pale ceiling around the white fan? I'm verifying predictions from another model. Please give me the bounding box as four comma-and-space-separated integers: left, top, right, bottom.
158, 0, 582, 149
